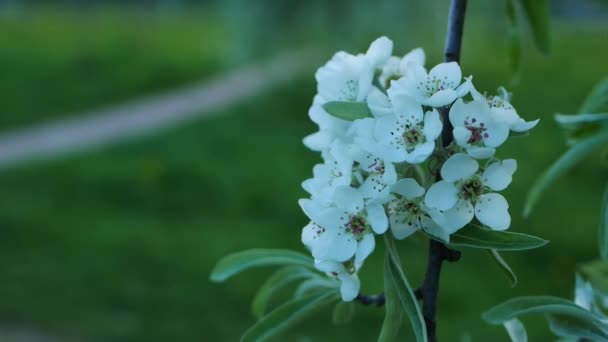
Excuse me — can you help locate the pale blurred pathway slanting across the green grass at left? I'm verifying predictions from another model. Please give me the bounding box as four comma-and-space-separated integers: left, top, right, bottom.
0, 50, 311, 168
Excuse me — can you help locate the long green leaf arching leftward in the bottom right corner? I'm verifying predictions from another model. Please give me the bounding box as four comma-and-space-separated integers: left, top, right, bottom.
482, 296, 601, 324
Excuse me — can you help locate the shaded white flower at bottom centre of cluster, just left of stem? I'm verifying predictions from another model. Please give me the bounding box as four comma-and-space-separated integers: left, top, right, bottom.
388, 178, 449, 242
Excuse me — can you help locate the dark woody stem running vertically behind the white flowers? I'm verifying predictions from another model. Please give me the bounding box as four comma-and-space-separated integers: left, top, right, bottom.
422, 0, 467, 342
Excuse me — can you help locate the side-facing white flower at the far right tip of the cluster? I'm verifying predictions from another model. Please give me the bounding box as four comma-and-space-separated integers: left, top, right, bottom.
471, 87, 540, 132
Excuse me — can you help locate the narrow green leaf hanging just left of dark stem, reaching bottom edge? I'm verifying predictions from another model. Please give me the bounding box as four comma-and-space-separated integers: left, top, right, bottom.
384, 234, 427, 342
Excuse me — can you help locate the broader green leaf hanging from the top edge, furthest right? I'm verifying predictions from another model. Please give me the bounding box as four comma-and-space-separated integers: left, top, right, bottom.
519, 0, 551, 54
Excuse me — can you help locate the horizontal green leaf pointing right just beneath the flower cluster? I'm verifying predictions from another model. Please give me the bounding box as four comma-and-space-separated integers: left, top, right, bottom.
450, 225, 548, 251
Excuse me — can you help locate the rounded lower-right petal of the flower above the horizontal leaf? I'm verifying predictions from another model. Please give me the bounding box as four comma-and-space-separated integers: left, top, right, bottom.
475, 193, 511, 230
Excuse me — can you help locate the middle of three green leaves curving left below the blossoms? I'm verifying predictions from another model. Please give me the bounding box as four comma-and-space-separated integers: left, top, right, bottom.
251, 266, 317, 318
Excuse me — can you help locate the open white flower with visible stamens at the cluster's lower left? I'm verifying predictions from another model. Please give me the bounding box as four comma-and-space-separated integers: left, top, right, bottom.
299, 186, 388, 262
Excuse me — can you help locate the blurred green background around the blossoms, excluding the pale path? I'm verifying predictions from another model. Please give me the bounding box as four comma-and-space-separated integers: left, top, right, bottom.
0, 0, 608, 341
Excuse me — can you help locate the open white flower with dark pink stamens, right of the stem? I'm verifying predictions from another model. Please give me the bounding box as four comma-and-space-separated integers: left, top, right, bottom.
450, 97, 509, 159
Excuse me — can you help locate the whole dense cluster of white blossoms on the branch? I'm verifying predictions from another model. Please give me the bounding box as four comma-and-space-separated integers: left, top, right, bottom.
299, 37, 538, 301
